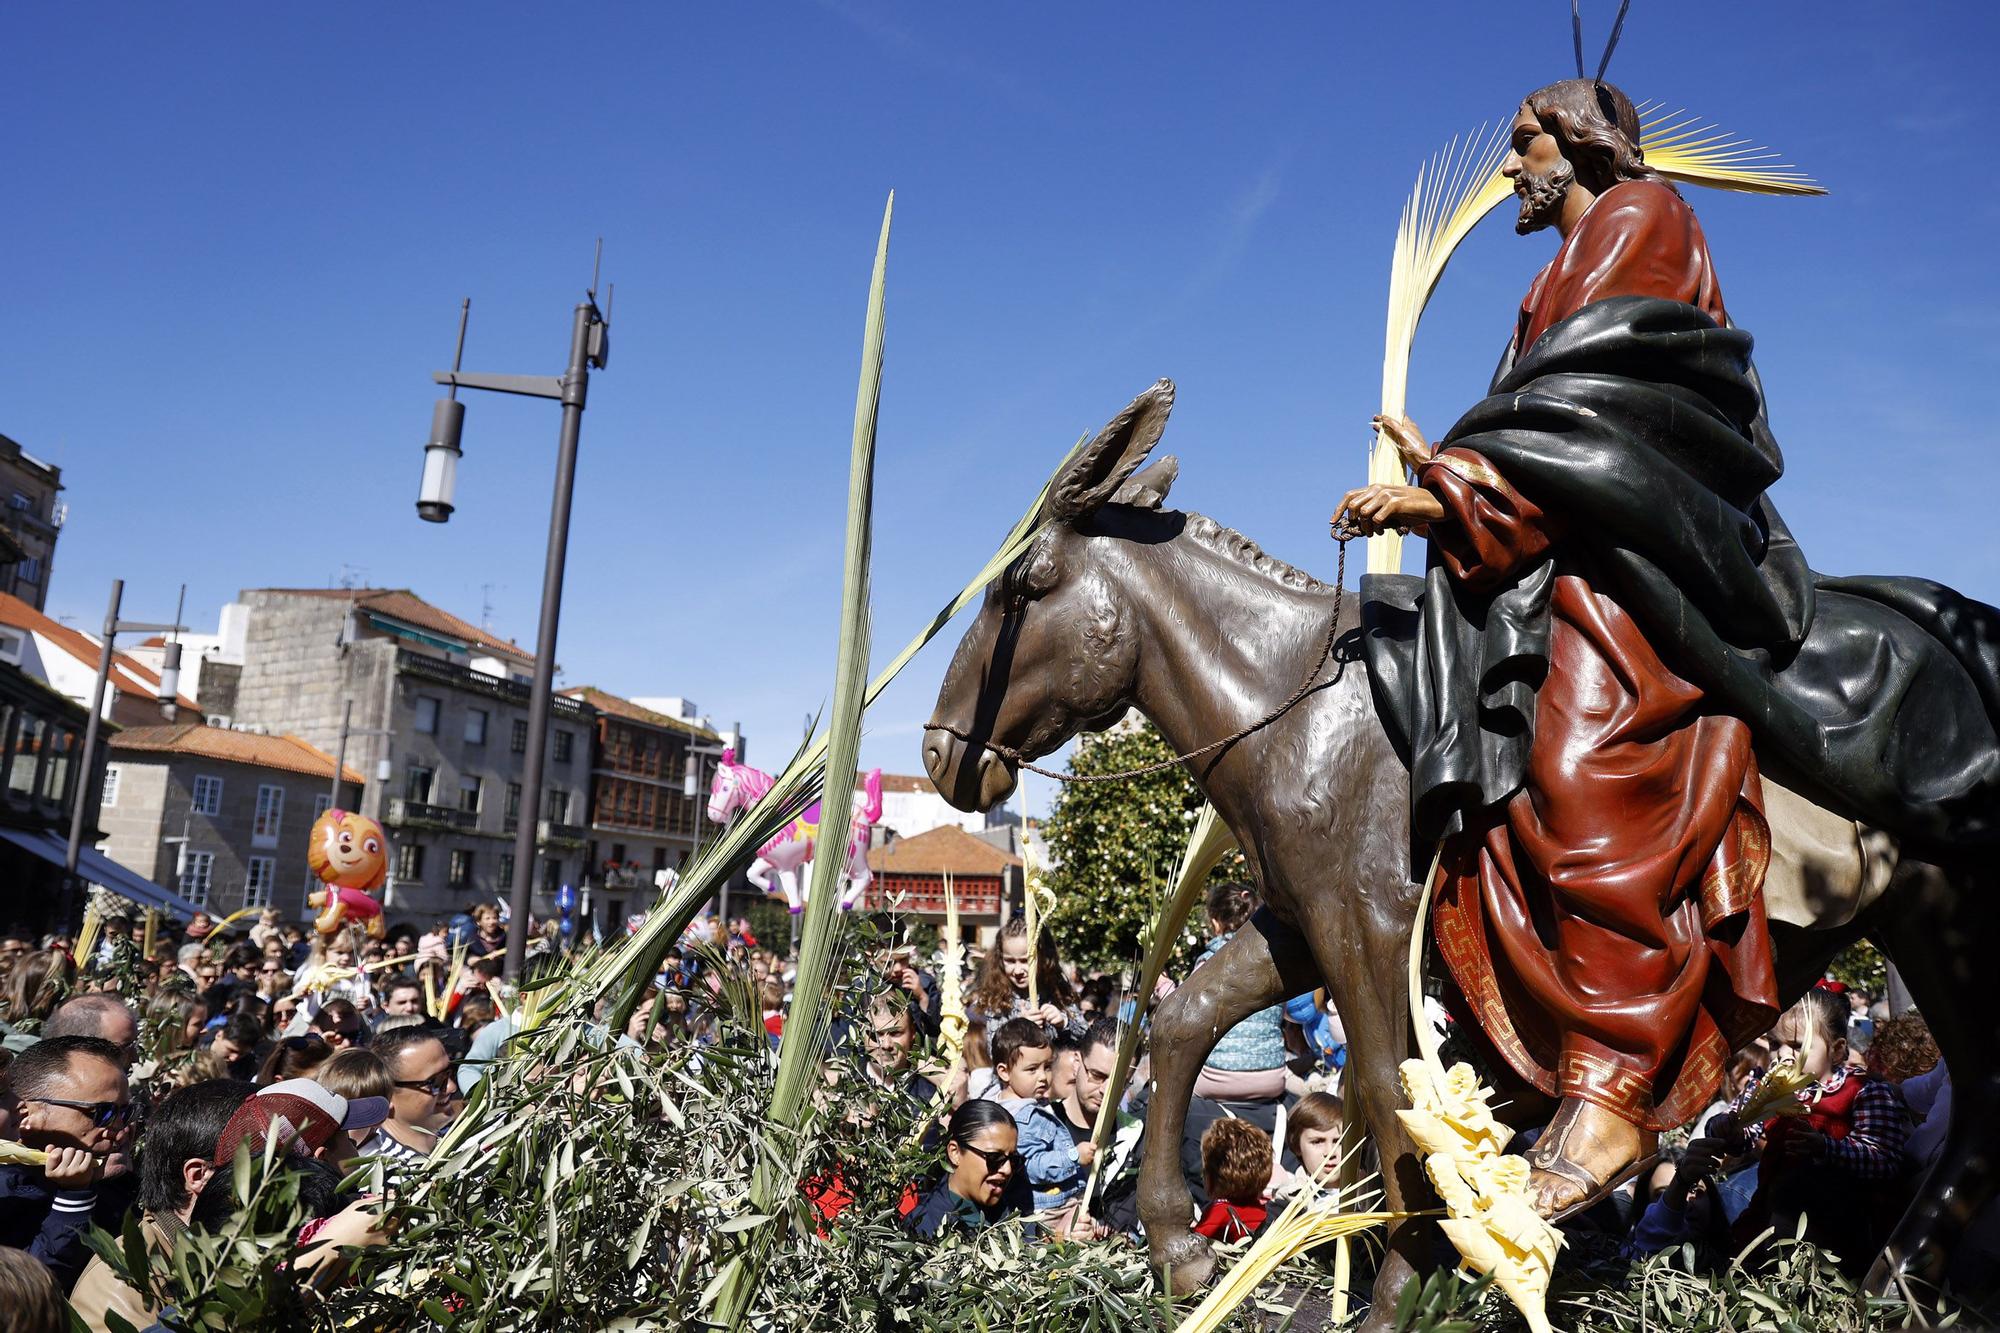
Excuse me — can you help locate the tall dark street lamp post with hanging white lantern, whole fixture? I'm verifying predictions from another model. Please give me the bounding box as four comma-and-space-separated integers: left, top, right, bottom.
416, 278, 610, 977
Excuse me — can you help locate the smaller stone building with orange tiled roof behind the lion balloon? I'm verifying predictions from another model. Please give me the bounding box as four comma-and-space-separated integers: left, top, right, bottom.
98, 723, 362, 921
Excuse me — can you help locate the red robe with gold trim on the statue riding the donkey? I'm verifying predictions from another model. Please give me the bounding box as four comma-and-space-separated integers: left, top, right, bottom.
1418, 180, 1778, 1129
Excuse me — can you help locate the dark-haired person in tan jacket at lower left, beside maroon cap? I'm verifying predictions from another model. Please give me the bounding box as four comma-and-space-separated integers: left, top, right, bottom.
70, 1079, 256, 1333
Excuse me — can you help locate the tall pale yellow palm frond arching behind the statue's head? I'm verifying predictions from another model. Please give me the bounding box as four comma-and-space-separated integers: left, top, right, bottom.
1368, 104, 1826, 574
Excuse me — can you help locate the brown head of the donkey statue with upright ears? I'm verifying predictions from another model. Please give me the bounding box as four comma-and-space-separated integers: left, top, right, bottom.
924, 380, 1176, 811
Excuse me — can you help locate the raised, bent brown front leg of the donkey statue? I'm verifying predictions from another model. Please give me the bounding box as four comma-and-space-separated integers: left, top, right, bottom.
1138, 909, 1320, 1295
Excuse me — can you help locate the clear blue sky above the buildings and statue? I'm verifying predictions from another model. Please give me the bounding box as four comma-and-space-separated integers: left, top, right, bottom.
0, 0, 2000, 805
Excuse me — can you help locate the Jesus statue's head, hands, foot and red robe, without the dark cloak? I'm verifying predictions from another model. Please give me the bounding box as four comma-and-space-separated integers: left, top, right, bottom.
1340, 78, 1782, 1217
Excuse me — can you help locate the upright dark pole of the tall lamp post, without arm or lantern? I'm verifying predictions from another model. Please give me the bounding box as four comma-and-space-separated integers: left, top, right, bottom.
506, 300, 596, 979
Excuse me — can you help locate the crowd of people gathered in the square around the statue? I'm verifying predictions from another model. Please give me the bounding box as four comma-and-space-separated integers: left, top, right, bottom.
0, 885, 1976, 1329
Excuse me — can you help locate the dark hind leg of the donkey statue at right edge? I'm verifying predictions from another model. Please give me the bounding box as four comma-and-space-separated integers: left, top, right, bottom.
1868, 863, 2000, 1291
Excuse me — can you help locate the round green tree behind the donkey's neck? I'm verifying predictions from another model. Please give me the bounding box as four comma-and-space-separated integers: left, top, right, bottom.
1042, 723, 1244, 975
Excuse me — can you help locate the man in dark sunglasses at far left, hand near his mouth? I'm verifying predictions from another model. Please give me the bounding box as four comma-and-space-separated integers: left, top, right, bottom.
0, 1037, 132, 1291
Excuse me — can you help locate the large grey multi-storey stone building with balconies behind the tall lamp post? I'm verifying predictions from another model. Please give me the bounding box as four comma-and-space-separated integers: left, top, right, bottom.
232, 588, 596, 923
